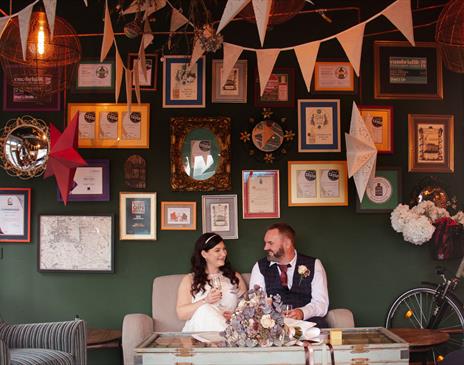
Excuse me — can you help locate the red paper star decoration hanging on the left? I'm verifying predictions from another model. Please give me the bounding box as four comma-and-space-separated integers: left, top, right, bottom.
44, 112, 87, 205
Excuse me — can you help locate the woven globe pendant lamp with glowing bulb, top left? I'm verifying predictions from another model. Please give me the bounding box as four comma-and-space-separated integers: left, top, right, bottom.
0, 0, 81, 98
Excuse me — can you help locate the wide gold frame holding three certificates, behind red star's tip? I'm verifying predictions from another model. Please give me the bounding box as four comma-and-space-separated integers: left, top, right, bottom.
68, 103, 150, 148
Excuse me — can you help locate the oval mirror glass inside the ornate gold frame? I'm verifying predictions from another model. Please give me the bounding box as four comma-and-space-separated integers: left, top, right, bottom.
182, 128, 221, 180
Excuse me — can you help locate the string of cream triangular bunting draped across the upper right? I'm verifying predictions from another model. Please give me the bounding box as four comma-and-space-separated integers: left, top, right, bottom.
221, 0, 415, 93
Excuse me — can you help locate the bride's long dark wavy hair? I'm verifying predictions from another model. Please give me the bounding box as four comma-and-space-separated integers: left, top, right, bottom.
190, 232, 238, 296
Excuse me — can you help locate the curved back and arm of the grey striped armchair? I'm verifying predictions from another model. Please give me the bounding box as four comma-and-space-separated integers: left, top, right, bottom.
1, 319, 87, 365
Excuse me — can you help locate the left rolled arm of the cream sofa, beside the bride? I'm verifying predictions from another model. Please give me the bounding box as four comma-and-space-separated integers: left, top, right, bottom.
122, 314, 154, 365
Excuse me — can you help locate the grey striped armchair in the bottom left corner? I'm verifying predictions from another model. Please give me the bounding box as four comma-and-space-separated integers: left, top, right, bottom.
0, 320, 87, 365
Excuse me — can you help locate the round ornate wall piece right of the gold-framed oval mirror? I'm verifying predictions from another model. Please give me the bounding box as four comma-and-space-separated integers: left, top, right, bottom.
240, 108, 295, 164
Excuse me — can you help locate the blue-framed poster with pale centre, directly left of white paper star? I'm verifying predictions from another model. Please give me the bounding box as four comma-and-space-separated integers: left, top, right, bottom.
298, 99, 340, 152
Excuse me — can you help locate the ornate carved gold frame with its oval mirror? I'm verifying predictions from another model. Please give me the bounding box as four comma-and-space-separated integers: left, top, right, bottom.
171, 117, 232, 191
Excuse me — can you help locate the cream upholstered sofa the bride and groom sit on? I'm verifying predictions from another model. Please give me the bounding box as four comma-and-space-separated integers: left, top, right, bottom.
122, 274, 354, 365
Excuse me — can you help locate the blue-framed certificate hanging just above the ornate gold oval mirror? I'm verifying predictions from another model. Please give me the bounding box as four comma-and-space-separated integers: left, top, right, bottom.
163, 56, 206, 108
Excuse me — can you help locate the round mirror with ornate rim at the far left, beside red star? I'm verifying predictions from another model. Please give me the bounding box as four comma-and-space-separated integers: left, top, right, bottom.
0, 115, 50, 179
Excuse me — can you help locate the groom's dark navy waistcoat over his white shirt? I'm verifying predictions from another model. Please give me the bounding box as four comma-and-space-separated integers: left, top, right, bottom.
258, 254, 316, 308
